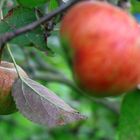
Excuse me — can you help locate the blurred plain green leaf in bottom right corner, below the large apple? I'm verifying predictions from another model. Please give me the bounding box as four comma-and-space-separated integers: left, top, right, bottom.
119, 90, 140, 140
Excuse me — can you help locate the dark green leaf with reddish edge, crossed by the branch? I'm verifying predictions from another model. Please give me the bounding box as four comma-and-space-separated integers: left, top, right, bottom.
0, 7, 50, 51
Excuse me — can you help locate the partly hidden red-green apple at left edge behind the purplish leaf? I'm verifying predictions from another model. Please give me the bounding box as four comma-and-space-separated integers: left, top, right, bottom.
0, 61, 27, 115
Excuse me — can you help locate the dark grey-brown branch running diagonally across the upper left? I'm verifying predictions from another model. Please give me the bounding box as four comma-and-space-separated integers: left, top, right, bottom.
0, 0, 79, 48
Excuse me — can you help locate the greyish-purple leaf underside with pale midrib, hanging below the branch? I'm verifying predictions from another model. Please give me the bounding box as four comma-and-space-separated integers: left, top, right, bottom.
12, 78, 85, 127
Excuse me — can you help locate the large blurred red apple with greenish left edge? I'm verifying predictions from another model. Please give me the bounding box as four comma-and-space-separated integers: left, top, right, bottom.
60, 1, 140, 97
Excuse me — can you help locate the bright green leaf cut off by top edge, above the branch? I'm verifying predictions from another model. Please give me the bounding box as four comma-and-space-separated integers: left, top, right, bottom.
17, 0, 48, 8
